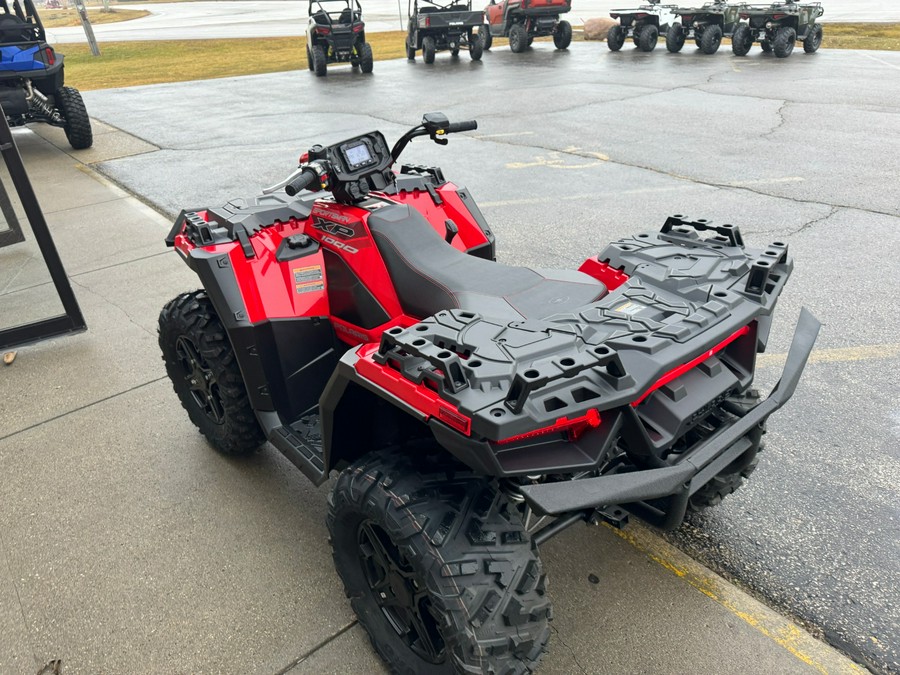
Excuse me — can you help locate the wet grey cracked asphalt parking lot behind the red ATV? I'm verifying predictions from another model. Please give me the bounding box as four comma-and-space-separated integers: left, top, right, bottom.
70, 43, 900, 672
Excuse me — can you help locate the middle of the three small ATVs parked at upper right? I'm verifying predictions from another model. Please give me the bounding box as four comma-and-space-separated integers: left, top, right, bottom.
666, 0, 750, 56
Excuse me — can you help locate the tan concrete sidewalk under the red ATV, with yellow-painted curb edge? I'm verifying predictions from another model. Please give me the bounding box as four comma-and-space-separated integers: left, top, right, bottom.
0, 124, 862, 675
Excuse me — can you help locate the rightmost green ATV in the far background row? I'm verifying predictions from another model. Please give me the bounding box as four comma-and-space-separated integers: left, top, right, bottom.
732, 0, 825, 59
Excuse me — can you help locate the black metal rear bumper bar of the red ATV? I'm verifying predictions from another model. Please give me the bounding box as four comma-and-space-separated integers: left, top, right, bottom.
520, 308, 821, 529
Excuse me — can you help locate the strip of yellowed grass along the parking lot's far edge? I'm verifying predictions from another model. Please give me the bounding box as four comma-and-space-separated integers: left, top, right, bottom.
59, 23, 900, 91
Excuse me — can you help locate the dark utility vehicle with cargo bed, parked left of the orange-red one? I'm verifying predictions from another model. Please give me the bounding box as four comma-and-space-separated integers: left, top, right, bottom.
406, 0, 484, 63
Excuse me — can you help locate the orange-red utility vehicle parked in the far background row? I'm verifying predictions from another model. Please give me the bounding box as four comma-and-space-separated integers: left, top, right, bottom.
482, 0, 572, 54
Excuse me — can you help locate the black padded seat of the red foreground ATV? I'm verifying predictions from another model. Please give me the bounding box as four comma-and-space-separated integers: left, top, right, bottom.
368, 204, 607, 321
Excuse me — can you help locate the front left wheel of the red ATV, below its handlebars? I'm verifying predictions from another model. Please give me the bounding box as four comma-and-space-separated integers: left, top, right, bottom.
159, 291, 265, 455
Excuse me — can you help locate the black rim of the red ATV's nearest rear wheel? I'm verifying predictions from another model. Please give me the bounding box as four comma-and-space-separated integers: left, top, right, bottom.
357, 520, 446, 664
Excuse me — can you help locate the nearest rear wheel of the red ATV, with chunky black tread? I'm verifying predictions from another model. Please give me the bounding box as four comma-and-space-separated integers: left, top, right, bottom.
327, 452, 551, 673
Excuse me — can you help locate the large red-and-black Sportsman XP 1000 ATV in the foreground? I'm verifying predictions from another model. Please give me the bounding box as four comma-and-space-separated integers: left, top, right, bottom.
159, 113, 819, 673
